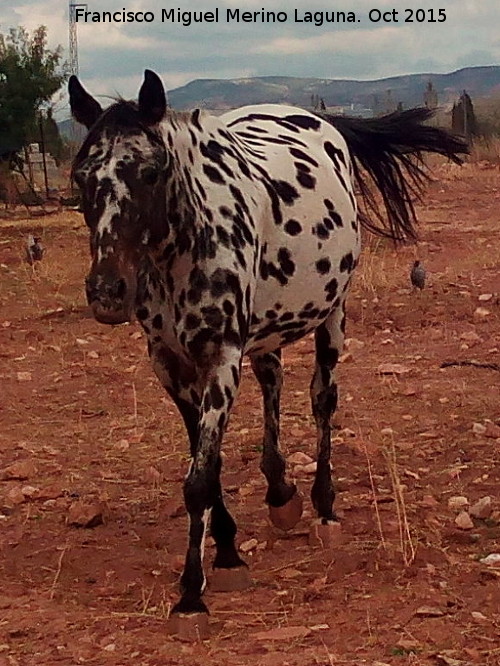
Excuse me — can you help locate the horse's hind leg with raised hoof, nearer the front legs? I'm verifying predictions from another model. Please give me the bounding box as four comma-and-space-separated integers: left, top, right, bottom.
250, 350, 302, 530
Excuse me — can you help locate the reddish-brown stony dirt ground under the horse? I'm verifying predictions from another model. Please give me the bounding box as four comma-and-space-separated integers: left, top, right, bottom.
0, 165, 500, 666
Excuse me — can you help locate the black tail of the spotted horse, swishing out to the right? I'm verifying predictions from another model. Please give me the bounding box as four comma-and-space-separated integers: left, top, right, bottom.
324, 108, 469, 242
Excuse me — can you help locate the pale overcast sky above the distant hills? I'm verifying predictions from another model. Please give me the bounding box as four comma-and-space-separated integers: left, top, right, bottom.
0, 0, 500, 116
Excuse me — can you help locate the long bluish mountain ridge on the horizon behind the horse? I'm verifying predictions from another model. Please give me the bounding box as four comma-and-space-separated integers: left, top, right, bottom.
59, 65, 500, 137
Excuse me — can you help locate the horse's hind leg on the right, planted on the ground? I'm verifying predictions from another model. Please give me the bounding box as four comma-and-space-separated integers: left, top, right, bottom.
310, 303, 345, 546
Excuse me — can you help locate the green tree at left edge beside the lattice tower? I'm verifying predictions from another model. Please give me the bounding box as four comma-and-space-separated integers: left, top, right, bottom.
0, 26, 66, 152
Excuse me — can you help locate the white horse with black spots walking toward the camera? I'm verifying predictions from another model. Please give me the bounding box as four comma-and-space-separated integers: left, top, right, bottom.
69, 70, 466, 635
